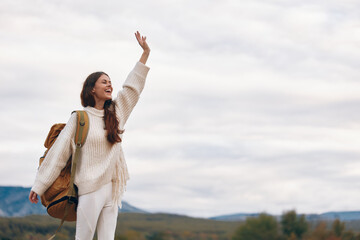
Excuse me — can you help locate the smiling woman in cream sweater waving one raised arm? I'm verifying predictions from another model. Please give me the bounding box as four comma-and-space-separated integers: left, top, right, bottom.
29, 32, 150, 240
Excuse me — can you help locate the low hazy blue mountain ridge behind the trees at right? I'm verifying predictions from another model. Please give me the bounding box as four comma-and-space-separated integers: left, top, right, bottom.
210, 211, 360, 222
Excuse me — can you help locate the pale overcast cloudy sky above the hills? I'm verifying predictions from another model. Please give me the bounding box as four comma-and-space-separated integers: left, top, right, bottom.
0, 0, 360, 217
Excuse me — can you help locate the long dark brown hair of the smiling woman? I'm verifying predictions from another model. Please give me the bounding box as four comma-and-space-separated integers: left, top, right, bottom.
80, 72, 123, 144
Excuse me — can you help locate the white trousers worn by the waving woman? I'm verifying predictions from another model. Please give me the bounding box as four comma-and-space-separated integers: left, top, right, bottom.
75, 182, 118, 240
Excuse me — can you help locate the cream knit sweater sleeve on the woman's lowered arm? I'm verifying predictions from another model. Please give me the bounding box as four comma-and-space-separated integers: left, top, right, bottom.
31, 113, 77, 196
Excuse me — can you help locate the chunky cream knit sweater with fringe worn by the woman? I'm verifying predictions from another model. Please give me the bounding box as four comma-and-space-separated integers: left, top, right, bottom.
31, 62, 149, 206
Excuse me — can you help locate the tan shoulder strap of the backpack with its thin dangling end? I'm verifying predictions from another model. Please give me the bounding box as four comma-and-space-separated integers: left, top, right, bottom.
48, 111, 89, 240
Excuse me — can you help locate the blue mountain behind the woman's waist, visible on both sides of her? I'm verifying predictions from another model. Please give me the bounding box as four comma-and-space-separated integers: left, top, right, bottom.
0, 186, 147, 217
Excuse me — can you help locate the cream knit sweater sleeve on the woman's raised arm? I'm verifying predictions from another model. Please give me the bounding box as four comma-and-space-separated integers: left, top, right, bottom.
115, 62, 150, 126
